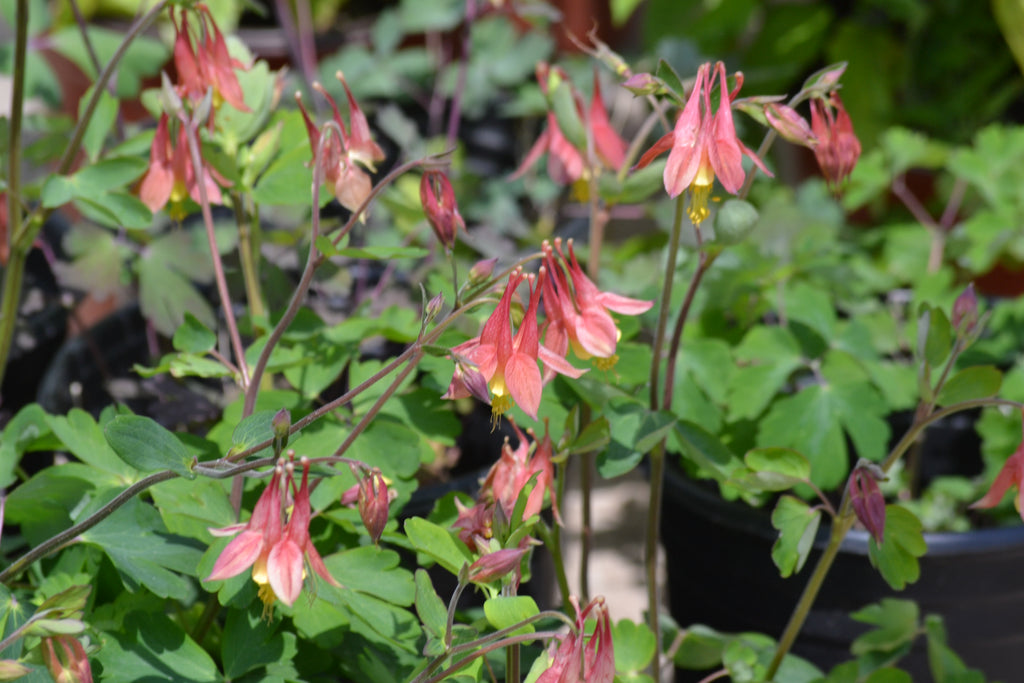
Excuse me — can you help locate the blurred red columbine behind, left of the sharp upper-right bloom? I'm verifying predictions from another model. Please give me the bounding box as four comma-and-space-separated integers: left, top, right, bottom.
511, 62, 627, 185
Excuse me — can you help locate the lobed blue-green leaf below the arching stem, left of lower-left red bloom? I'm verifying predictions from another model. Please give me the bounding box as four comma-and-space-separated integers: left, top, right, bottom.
81, 498, 203, 600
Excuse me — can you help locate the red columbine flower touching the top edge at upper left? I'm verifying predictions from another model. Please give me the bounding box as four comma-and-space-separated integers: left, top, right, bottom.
171, 4, 252, 112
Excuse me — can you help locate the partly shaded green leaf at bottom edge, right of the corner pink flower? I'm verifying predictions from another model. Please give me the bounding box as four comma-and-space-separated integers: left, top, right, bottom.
95, 611, 223, 683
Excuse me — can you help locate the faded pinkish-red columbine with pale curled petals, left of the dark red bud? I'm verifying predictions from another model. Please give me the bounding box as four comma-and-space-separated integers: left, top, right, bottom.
295, 72, 384, 216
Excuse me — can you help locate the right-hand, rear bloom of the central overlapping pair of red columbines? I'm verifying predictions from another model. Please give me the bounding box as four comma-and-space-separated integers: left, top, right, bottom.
543, 240, 653, 370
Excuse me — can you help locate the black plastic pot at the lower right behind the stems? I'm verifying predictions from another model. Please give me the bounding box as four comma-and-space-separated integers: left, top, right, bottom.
662, 466, 1024, 681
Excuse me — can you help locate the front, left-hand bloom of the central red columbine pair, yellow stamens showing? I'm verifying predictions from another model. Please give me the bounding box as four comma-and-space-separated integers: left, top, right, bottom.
443, 268, 586, 420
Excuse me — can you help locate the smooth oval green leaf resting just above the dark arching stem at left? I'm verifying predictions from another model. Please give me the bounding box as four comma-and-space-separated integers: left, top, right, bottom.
103, 415, 196, 479
